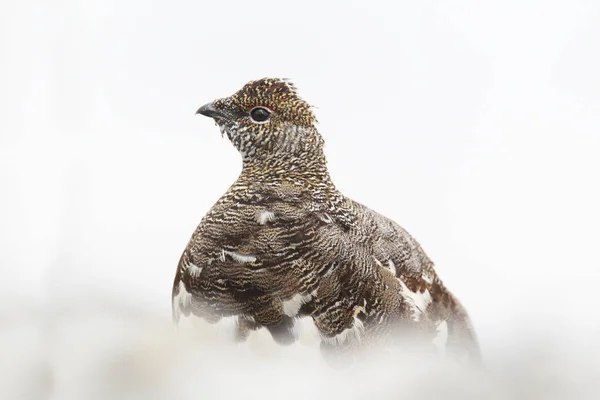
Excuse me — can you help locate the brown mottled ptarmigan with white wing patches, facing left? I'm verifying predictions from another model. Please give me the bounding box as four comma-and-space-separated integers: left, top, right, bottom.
172, 78, 481, 361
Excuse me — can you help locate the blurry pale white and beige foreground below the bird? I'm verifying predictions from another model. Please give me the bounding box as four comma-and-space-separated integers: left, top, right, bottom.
0, 295, 600, 399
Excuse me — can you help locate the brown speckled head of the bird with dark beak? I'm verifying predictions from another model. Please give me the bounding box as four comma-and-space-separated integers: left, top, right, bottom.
197, 78, 323, 161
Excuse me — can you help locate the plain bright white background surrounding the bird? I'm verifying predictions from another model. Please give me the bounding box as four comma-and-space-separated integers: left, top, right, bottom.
0, 0, 600, 398
